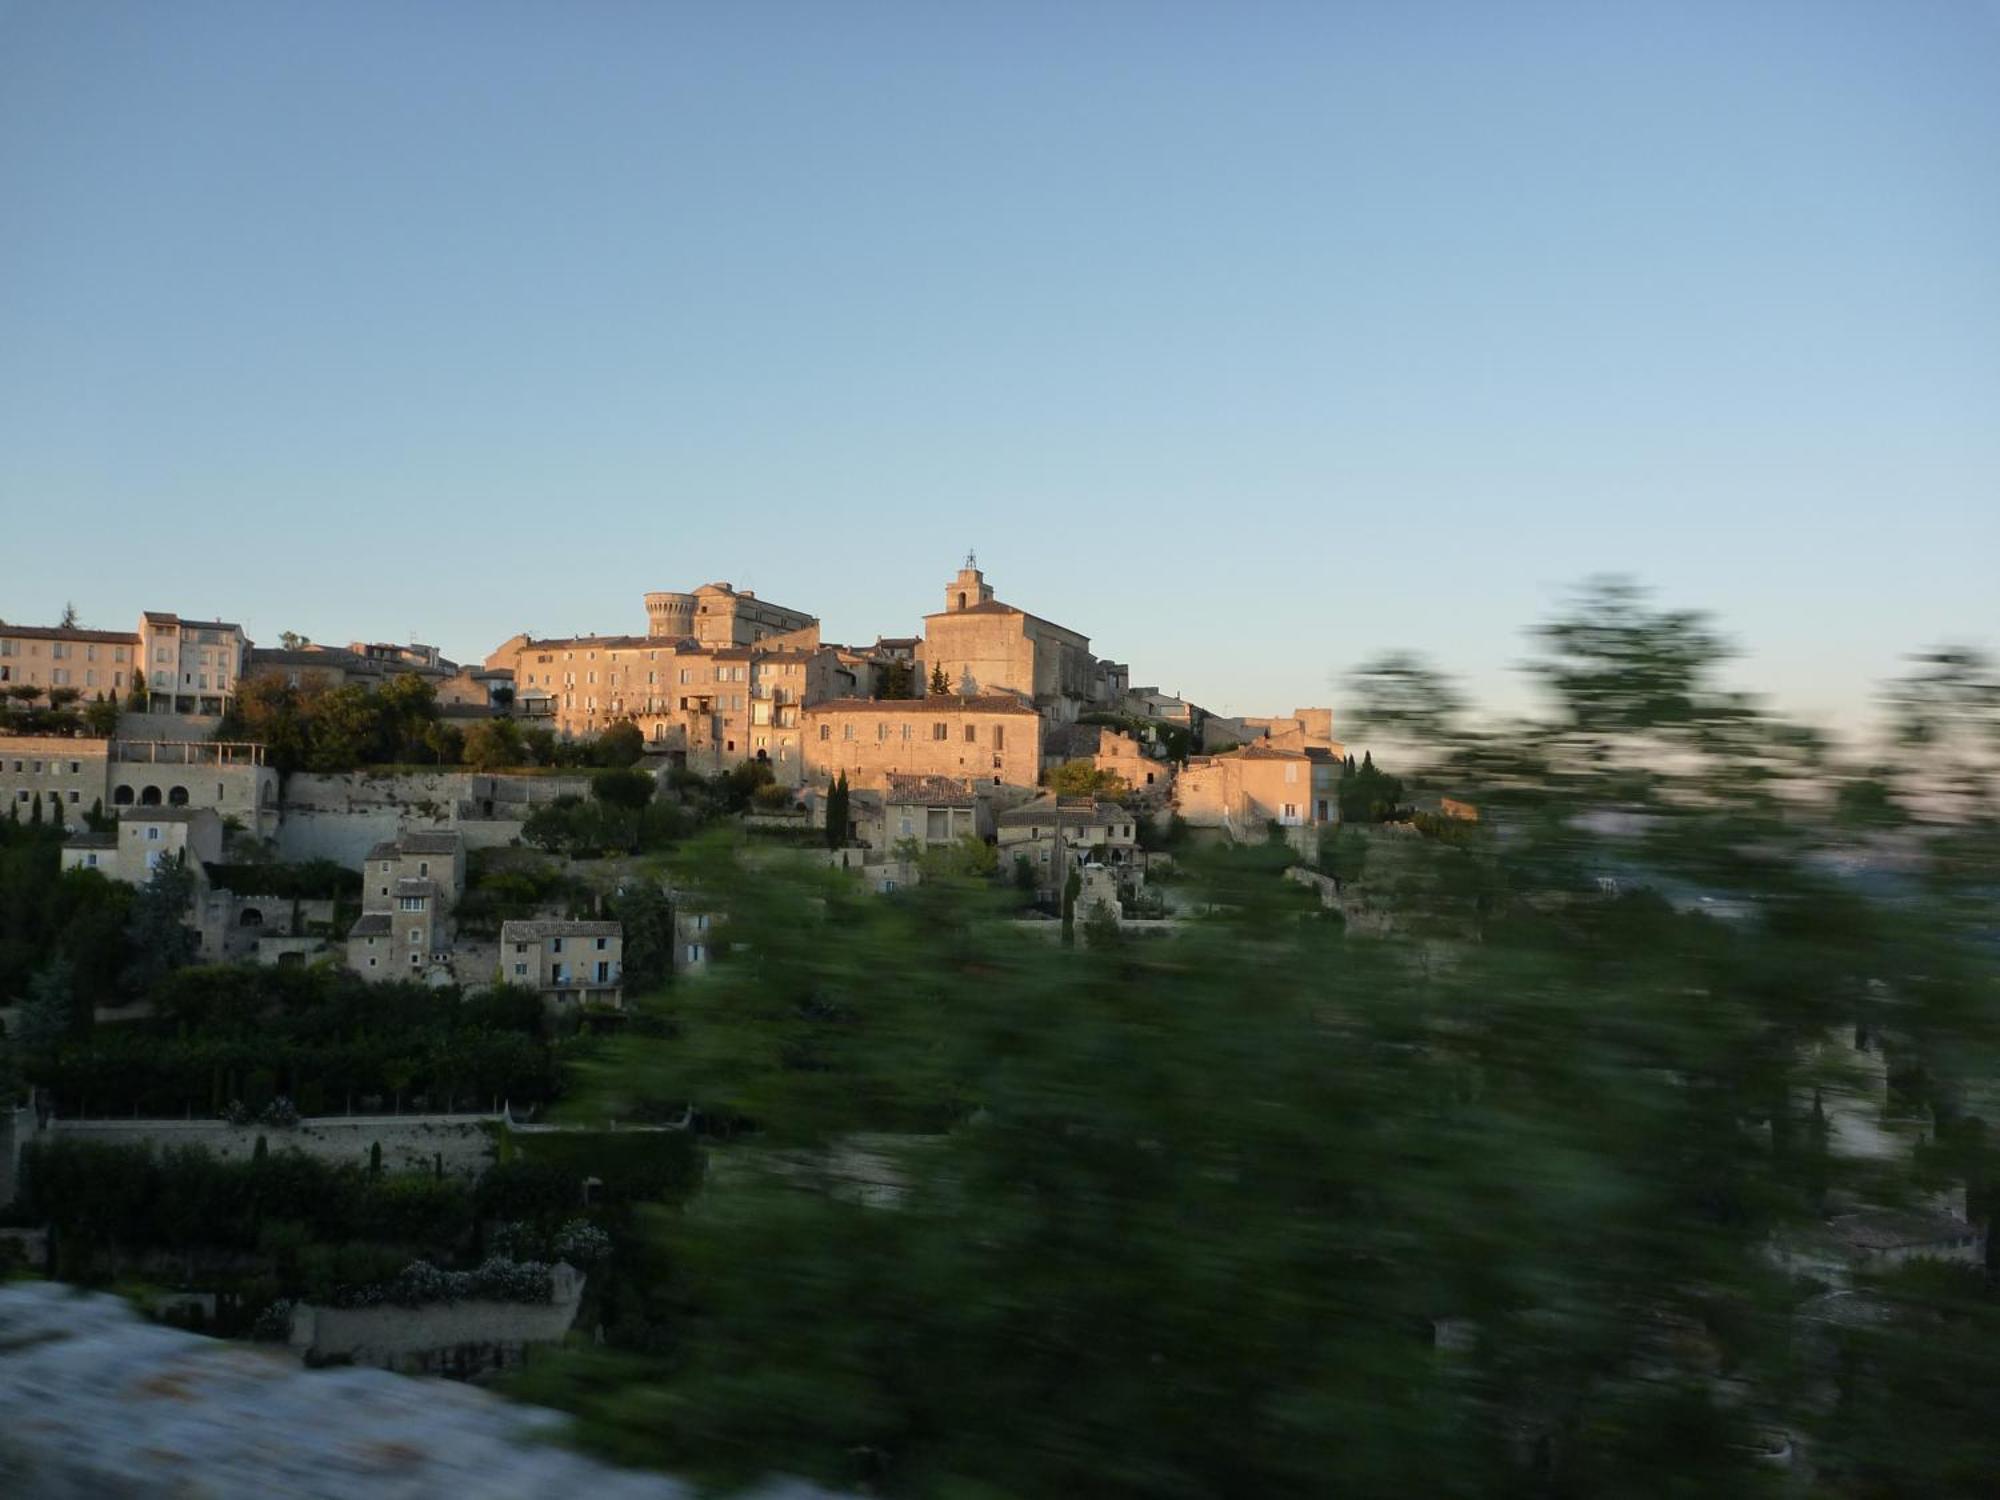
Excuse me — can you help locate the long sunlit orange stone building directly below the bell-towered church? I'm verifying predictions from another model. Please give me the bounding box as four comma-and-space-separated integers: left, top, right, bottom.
802, 694, 1042, 790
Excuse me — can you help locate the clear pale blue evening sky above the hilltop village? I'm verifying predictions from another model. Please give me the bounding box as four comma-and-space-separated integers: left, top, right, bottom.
0, 0, 2000, 728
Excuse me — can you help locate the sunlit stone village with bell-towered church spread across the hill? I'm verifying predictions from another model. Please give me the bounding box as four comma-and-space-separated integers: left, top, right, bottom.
0, 556, 1354, 1008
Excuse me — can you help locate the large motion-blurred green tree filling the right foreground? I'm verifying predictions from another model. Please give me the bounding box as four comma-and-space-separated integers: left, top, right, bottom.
532, 580, 2000, 1500
